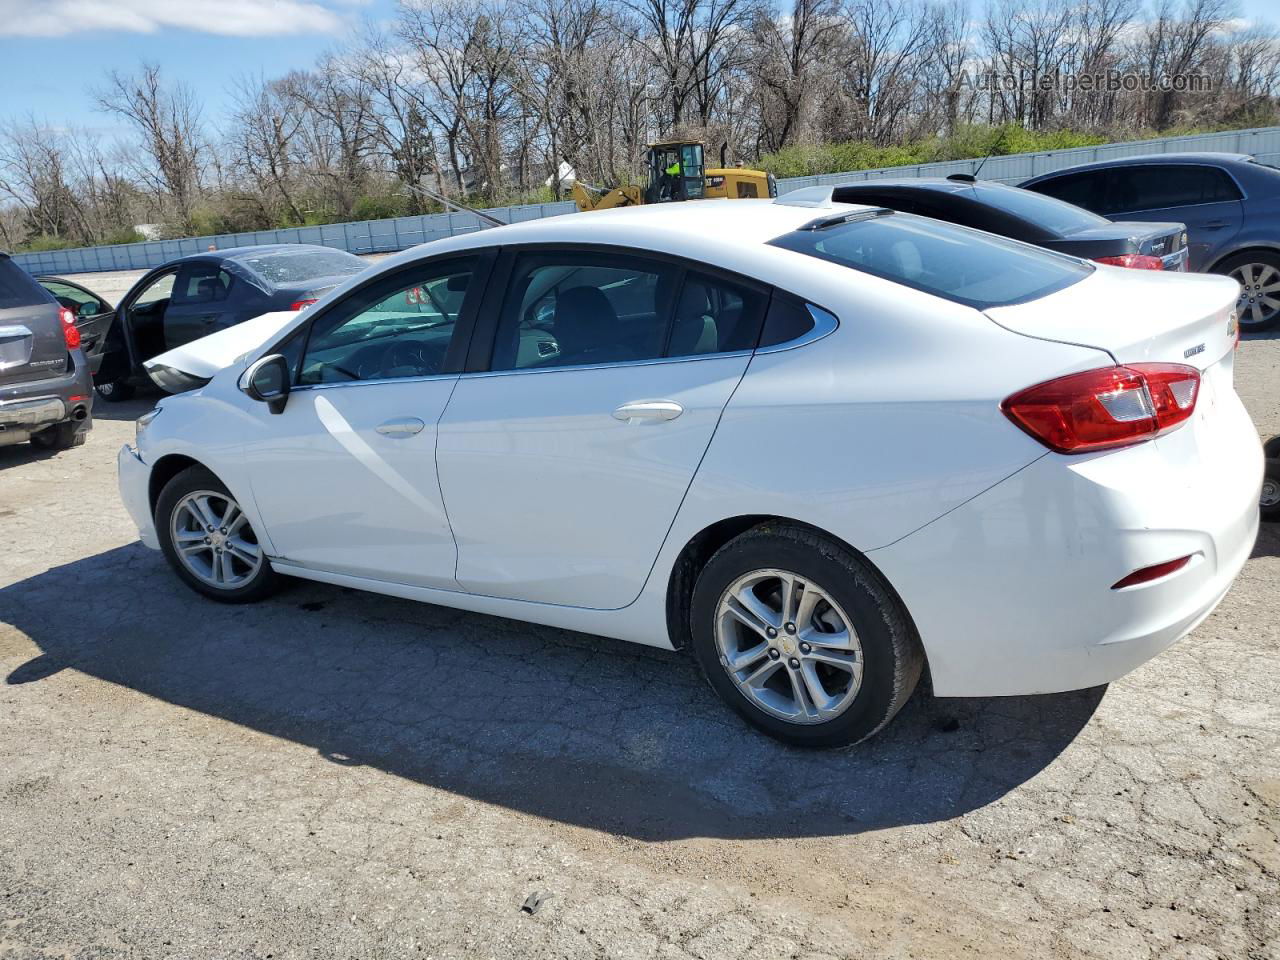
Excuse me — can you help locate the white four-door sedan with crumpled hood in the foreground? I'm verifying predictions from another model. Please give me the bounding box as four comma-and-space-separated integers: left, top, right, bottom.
119, 191, 1262, 745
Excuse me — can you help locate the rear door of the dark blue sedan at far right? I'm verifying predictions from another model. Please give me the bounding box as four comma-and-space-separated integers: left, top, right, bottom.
1101, 164, 1244, 271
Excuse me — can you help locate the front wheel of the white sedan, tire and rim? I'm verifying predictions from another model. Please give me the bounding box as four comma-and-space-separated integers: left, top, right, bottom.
155, 467, 279, 603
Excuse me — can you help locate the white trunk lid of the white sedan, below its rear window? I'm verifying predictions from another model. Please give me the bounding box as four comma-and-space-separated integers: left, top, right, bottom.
986, 271, 1239, 371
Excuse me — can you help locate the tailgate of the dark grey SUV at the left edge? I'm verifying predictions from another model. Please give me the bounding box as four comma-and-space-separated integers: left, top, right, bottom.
0, 256, 68, 384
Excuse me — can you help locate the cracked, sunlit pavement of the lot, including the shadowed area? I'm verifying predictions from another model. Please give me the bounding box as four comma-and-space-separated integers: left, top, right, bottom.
0, 278, 1280, 960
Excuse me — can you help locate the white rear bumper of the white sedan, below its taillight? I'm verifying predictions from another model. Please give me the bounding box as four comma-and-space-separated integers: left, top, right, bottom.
869, 392, 1262, 696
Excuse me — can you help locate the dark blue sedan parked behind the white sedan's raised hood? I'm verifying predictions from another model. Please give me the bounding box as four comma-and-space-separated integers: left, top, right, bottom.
93, 243, 366, 401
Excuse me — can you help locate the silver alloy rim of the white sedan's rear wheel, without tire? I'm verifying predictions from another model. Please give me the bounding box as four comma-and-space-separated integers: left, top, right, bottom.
716, 570, 863, 723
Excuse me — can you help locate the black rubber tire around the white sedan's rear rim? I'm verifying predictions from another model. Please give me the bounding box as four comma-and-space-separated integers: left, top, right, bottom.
690, 524, 924, 748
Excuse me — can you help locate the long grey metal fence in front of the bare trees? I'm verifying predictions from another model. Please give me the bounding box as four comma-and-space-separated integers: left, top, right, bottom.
13, 127, 1280, 274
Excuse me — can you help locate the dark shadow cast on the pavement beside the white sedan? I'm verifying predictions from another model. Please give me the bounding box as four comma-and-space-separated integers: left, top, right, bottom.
0, 544, 1105, 841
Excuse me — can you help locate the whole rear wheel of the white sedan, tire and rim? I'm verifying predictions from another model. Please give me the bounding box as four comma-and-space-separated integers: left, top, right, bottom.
690, 524, 924, 746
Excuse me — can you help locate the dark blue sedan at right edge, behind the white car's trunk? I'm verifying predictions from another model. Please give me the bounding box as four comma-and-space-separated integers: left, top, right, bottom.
1021, 154, 1280, 330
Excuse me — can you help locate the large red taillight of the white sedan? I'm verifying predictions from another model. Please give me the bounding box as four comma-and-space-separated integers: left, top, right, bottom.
1000, 364, 1199, 453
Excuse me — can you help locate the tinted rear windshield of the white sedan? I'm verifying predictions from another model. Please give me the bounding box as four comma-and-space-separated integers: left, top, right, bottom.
771, 214, 1093, 310
